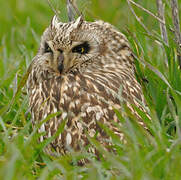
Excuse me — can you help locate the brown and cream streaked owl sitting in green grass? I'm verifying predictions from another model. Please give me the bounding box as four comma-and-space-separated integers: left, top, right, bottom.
27, 16, 145, 158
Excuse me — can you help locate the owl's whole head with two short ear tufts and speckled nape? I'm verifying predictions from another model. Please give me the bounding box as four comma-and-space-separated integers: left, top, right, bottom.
32, 16, 129, 74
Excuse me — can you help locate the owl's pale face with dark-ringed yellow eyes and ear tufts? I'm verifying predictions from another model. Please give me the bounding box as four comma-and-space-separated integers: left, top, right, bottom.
37, 16, 109, 74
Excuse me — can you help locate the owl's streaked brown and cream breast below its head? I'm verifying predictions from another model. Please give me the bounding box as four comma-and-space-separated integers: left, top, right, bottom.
29, 63, 147, 153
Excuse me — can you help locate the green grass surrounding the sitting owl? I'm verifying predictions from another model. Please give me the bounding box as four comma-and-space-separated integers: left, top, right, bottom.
0, 0, 181, 180
